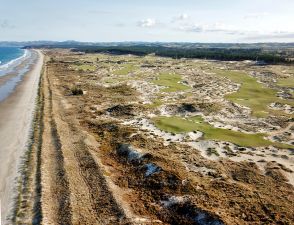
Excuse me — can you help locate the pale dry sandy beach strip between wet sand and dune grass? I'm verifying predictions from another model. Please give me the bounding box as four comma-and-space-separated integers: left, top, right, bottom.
0, 52, 43, 223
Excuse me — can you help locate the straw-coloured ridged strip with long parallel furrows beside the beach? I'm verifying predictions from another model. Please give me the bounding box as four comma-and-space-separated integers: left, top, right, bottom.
42, 59, 127, 224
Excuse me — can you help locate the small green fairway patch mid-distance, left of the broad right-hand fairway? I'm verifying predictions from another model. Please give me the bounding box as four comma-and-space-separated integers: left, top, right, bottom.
153, 73, 190, 92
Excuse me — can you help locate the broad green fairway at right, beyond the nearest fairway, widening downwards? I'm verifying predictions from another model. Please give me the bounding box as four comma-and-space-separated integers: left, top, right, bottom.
214, 70, 293, 117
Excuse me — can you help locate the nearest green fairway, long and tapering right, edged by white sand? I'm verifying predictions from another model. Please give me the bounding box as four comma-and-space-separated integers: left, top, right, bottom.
153, 116, 293, 148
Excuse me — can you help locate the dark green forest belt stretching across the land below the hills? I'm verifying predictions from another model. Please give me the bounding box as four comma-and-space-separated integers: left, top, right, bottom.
69, 45, 291, 63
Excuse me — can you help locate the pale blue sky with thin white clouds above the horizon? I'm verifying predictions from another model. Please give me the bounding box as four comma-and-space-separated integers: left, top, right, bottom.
0, 0, 294, 43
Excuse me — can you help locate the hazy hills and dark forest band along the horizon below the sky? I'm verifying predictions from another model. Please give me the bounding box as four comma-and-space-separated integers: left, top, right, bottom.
0, 40, 294, 63
